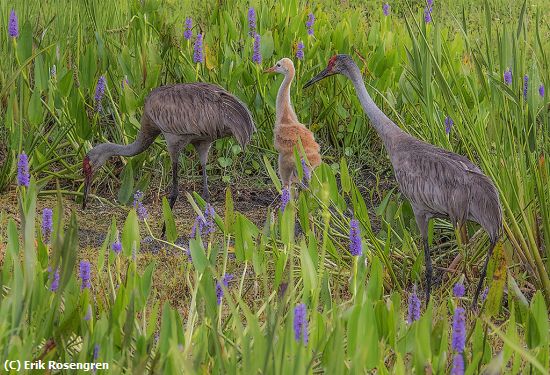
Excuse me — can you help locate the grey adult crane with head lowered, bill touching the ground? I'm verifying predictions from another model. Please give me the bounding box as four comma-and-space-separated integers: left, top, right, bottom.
82, 83, 256, 232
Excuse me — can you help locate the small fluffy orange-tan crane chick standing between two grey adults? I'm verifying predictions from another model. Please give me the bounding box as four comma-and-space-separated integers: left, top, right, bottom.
265, 57, 321, 188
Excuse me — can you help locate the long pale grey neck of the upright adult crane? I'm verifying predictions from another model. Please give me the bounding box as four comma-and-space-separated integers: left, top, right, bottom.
344, 63, 406, 149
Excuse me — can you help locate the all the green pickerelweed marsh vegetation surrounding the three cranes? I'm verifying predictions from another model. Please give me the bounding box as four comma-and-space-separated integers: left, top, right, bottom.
0, 0, 550, 374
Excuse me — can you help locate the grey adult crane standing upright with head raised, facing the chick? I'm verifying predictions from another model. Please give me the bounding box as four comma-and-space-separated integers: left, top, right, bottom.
304, 55, 502, 306
